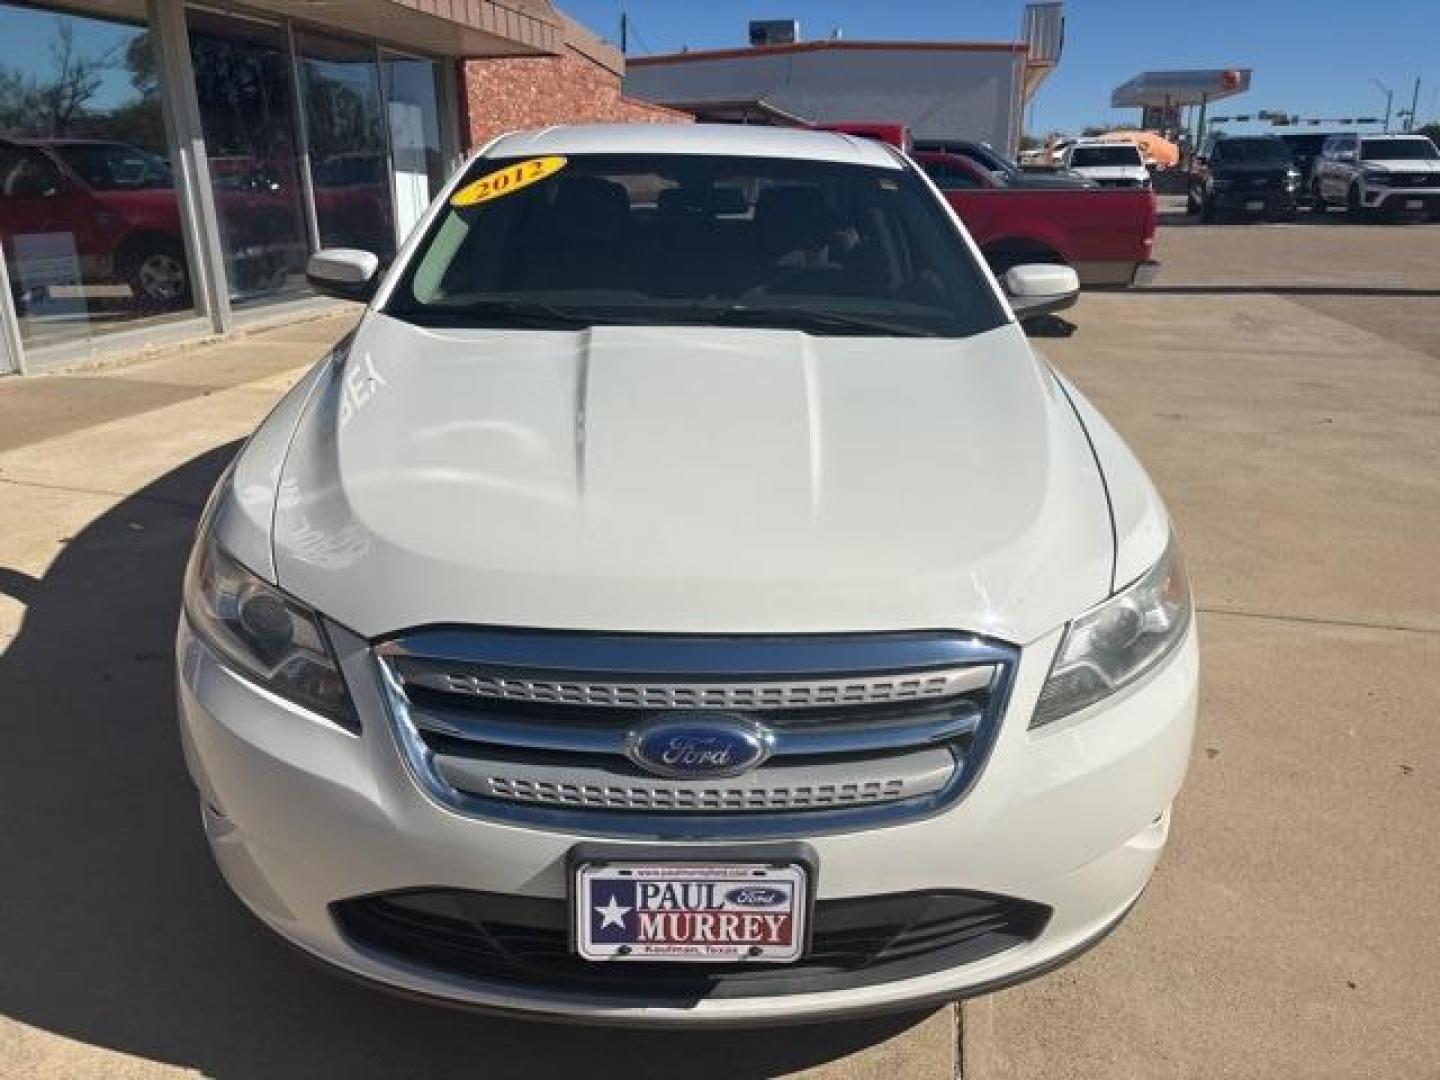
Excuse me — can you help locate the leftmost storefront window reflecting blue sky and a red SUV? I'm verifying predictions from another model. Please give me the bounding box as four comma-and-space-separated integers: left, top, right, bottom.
0, 3, 193, 346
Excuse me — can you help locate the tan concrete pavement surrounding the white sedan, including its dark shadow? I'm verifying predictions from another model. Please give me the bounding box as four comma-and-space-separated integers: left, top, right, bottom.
0, 216, 1440, 1080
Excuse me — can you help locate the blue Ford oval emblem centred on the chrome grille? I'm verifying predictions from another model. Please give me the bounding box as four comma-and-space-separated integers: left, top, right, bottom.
625, 713, 772, 780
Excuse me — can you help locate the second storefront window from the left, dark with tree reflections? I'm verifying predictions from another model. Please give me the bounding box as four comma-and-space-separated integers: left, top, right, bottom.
189, 10, 310, 305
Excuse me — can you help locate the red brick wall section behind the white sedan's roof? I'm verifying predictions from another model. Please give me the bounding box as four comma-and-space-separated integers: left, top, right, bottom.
461, 48, 694, 147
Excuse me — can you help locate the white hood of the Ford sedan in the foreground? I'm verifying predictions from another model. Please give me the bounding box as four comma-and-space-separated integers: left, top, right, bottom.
272, 314, 1115, 642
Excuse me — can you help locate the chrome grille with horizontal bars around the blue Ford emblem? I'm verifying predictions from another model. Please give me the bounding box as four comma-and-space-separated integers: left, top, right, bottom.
374, 631, 1015, 838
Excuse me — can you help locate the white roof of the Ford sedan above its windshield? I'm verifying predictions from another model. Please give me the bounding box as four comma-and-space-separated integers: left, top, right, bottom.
485, 124, 903, 168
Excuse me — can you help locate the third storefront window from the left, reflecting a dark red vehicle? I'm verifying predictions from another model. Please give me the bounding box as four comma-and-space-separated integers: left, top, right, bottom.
297, 33, 395, 258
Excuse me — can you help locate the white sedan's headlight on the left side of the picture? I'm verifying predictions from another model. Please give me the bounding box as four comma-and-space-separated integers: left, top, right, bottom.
184, 536, 359, 730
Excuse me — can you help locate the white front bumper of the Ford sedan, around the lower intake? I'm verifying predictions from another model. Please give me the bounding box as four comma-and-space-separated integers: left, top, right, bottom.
177, 625, 1197, 1024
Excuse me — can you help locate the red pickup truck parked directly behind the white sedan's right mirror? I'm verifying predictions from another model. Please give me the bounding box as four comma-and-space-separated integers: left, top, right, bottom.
914, 153, 1159, 287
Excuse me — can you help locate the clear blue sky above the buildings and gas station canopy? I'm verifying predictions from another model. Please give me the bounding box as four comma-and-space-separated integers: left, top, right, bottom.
557, 0, 1440, 134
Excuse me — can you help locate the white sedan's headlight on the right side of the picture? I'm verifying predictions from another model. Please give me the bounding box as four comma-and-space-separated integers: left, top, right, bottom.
1030, 537, 1191, 727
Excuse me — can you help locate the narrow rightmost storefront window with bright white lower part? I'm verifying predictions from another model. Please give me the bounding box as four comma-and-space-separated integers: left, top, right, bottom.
380, 53, 445, 238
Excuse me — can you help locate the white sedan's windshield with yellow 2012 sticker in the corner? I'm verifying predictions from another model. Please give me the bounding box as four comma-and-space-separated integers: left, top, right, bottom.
384, 154, 1005, 337
